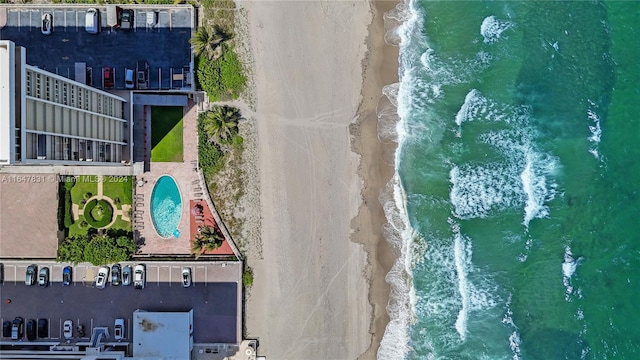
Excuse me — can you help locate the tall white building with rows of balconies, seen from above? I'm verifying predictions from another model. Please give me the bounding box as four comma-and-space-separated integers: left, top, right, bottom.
0, 40, 133, 167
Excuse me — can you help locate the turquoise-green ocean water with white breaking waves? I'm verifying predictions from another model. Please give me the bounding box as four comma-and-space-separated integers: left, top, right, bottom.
378, 0, 640, 360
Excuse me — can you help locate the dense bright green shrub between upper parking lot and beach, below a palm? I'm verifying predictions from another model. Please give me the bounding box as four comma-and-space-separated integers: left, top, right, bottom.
196, 44, 247, 101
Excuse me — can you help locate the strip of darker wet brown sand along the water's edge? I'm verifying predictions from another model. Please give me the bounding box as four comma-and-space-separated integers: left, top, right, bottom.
351, 1, 399, 359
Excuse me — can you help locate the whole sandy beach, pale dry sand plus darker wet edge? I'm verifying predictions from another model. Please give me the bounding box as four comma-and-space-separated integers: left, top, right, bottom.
238, 1, 397, 359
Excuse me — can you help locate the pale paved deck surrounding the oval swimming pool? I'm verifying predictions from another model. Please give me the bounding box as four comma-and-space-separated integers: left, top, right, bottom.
133, 101, 240, 258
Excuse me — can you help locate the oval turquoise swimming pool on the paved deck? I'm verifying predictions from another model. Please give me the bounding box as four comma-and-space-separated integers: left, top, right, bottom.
151, 175, 182, 238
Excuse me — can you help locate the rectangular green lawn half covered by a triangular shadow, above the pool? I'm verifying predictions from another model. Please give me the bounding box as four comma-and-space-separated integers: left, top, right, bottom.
151, 106, 183, 162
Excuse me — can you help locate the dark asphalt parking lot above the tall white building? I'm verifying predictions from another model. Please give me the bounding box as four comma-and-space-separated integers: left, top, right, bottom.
0, 5, 193, 90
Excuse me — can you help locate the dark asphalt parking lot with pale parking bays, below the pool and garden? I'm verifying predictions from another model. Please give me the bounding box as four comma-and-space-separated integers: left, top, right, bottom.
0, 262, 241, 343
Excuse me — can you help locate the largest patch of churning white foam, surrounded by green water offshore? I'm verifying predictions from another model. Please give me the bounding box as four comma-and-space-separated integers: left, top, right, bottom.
450, 89, 558, 227
